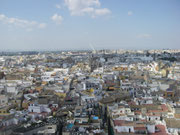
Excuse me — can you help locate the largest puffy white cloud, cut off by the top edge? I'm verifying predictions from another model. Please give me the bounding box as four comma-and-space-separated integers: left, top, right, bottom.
64, 0, 111, 17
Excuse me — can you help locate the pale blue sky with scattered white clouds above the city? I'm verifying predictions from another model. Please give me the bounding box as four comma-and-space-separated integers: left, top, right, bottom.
0, 0, 180, 51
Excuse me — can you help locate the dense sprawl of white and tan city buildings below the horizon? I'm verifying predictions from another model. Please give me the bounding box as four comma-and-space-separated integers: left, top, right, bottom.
0, 51, 180, 135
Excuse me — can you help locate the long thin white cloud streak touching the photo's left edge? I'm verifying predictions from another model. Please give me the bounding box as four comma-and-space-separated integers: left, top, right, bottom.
0, 14, 46, 31
